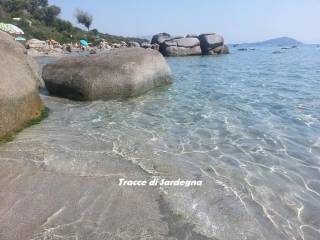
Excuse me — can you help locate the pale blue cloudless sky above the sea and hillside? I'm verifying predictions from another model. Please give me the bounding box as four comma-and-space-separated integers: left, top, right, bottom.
49, 0, 320, 43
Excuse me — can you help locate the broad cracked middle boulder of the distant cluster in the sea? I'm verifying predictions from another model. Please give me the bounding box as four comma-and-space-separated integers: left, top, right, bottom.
160, 37, 201, 56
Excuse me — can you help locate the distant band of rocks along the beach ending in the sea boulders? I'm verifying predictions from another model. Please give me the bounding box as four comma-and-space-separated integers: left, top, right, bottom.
26, 33, 229, 56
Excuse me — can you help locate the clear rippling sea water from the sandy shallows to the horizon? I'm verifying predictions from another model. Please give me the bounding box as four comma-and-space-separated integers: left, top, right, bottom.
4, 47, 320, 240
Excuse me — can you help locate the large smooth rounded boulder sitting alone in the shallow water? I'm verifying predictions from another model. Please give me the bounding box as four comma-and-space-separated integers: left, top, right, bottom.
43, 48, 171, 101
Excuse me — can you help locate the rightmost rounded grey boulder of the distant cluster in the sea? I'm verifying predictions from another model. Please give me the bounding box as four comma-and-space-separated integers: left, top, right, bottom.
199, 33, 224, 55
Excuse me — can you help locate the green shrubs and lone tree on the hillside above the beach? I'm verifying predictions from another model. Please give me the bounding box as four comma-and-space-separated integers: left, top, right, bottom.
0, 0, 147, 43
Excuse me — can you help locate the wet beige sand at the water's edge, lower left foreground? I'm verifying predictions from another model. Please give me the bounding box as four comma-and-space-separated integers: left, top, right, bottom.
0, 94, 209, 240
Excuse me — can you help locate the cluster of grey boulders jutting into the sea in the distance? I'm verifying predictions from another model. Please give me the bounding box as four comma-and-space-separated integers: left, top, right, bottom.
151, 33, 229, 56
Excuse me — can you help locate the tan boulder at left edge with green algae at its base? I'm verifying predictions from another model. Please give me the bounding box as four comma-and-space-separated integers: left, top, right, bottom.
0, 31, 43, 138
